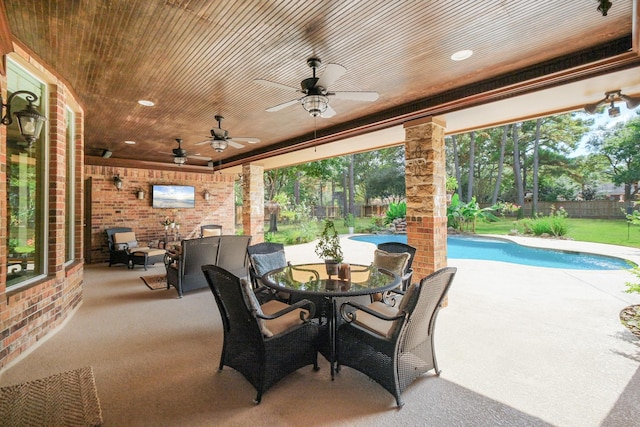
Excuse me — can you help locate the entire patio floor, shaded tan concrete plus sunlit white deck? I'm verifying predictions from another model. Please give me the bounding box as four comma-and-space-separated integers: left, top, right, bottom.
0, 239, 640, 427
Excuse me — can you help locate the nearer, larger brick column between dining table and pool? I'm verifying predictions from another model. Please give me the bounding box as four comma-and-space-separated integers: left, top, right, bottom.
404, 117, 447, 282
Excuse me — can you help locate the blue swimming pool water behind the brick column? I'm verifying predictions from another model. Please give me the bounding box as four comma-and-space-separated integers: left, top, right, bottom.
350, 234, 631, 270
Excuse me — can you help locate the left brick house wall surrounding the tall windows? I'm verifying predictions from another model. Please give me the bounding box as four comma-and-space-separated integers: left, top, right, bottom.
0, 46, 83, 370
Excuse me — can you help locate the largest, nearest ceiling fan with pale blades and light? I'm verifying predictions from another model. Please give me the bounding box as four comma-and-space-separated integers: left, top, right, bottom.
254, 58, 378, 118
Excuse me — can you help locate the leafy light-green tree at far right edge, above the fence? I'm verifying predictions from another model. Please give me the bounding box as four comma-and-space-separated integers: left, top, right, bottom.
588, 117, 640, 200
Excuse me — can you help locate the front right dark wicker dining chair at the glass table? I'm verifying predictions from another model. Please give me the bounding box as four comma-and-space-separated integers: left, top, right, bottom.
337, 267, 456, 407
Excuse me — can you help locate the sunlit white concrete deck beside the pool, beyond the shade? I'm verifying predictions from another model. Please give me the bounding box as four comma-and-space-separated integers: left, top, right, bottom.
286, 237, 640, 426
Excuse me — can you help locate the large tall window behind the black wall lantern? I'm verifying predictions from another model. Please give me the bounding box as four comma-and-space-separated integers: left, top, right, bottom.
6, 59, 48, 287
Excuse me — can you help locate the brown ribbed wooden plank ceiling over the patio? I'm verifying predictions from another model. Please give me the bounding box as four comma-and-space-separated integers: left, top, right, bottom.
4, 0, 637, 171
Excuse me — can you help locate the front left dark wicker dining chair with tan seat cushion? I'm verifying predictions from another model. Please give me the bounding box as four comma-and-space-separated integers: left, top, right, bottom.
202, 265, 318, 404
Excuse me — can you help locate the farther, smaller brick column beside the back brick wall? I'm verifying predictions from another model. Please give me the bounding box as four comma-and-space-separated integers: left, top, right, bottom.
242, 164, 264, 244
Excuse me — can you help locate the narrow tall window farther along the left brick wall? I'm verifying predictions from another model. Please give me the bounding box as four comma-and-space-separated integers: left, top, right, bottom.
64, 109, 76, 262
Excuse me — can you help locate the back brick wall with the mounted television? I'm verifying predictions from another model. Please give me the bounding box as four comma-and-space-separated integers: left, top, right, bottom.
85, 166, 236, 263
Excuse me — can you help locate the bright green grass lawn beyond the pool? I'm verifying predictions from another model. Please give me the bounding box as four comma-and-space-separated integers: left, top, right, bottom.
265, 218, 640, 248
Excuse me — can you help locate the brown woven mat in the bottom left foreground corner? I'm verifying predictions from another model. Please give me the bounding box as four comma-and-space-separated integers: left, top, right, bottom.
0, 367, 102, 427
